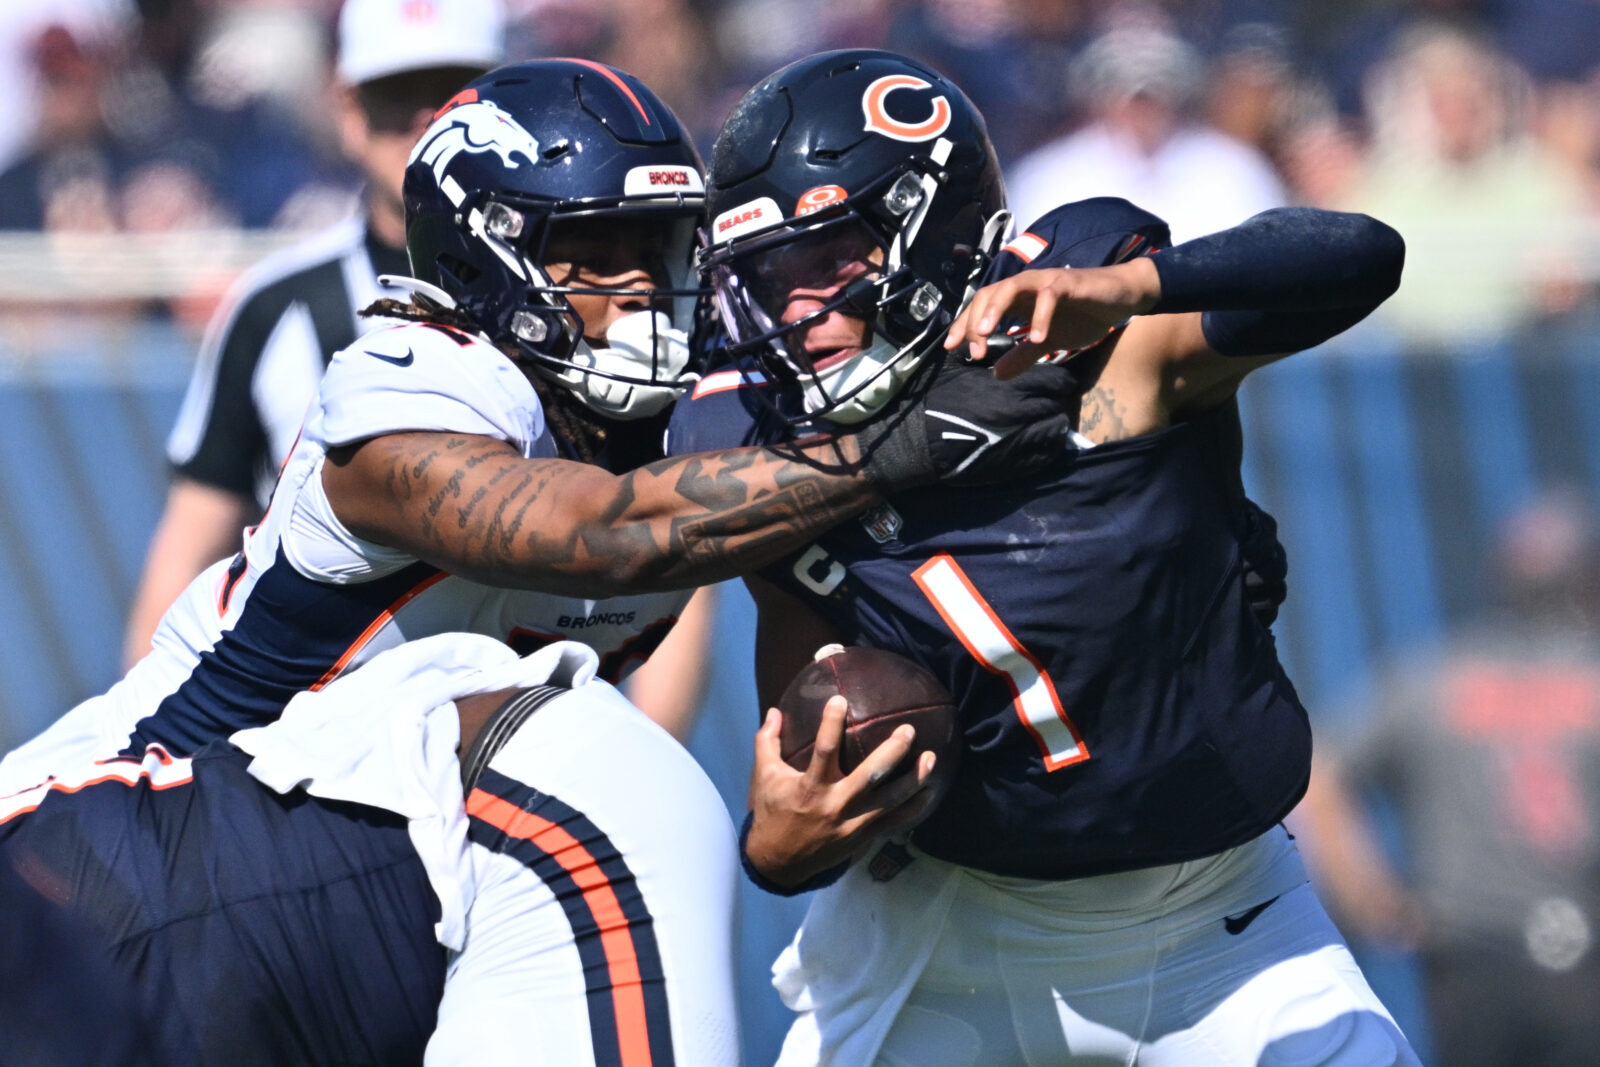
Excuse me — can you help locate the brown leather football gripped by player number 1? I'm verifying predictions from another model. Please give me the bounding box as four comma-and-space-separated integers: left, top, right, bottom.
778, 645, 962, 803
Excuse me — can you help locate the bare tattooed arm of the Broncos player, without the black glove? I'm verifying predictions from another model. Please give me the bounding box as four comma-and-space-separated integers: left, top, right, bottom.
323, 434, 878, 597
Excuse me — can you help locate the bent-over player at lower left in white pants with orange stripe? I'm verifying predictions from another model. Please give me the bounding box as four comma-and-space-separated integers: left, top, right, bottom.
0, 633, 739, 1067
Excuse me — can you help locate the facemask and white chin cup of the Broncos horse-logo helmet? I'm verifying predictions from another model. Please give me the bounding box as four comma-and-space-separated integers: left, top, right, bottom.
482, 194, 702, 419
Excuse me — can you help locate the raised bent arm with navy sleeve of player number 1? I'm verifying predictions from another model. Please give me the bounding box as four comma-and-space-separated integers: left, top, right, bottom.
946, 208, 1405, 432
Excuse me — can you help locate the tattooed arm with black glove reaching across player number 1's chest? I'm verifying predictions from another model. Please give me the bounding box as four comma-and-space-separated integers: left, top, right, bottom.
322, 355, 1070, 597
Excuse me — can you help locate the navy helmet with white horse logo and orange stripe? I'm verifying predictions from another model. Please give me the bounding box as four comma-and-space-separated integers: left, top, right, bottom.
403, 59, 706, 419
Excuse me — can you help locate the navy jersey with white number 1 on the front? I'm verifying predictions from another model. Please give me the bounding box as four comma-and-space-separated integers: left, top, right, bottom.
669, 202, 1310, 878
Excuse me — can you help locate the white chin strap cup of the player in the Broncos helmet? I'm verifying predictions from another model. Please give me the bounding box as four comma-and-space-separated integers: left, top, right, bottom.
539, 310, 699, 421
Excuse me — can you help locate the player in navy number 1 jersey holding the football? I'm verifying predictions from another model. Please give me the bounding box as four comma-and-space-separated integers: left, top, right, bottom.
669, 51, 1416, 1067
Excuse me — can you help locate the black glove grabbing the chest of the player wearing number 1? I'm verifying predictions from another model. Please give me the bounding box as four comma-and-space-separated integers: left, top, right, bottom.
856, 357, 1075, 494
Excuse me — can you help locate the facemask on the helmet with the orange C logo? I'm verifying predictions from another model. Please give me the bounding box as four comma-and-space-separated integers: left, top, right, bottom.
704, 160, 987, 422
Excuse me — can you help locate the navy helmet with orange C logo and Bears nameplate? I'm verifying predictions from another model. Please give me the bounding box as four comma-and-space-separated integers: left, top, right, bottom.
701, 50, 1010, 422
